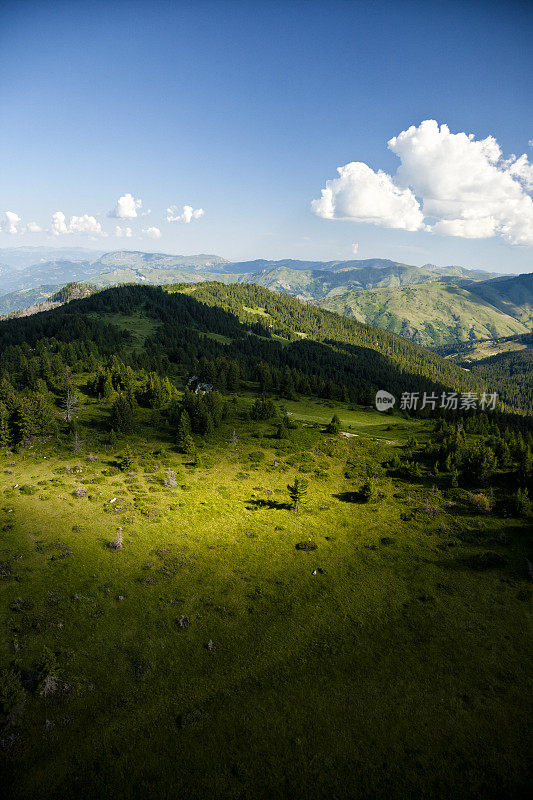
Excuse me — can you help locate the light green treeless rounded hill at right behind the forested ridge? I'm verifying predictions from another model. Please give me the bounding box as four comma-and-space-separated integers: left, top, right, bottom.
320, 283, 529, 345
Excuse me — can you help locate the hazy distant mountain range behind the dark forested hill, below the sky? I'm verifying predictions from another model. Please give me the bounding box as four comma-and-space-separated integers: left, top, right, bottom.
0, 247, 533, 347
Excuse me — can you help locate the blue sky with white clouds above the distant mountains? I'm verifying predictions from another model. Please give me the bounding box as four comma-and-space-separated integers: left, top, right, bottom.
0, 0, 533, 272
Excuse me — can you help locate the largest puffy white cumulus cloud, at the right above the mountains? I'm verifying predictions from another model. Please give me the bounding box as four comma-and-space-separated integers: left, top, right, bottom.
312, 120, 533, 244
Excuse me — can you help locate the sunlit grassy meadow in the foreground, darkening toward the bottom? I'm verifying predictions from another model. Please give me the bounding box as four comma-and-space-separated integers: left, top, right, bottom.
0, 390, 531, 800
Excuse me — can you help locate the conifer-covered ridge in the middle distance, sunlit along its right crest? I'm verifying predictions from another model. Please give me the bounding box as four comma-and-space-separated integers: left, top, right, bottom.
0, 282, 482, 403
